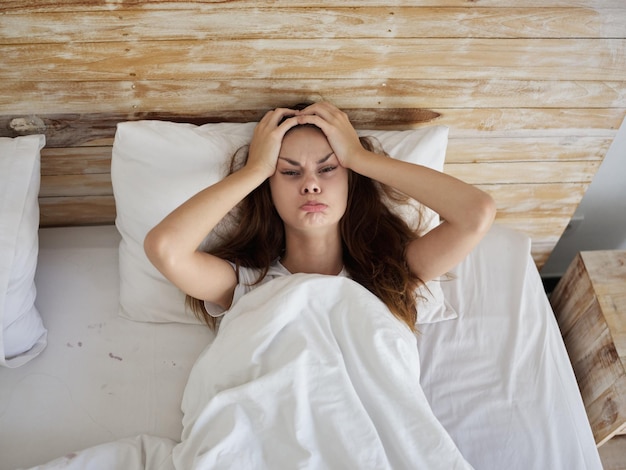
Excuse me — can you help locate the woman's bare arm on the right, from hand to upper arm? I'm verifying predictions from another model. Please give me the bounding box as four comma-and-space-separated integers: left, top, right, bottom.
299, 103, 496, 281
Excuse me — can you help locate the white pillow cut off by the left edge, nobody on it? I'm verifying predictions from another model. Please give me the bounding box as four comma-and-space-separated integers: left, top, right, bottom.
0, 135, 47, 367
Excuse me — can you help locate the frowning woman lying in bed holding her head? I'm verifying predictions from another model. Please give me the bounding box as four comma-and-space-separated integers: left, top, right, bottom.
144, 102, 495, 329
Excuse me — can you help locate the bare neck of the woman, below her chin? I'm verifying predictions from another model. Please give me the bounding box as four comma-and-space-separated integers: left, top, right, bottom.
280, 229, 343, 275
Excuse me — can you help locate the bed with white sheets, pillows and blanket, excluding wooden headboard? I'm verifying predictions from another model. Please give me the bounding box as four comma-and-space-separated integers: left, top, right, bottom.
0, 120, 601, 469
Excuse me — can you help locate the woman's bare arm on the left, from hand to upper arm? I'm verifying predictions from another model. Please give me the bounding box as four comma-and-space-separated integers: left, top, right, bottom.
144, 109, 297, 308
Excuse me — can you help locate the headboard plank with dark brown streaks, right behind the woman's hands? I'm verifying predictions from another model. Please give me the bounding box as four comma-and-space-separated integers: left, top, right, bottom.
0, 112, 626, 149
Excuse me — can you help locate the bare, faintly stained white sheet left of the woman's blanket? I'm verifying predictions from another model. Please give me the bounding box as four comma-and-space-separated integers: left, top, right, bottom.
0, 226, 213, 470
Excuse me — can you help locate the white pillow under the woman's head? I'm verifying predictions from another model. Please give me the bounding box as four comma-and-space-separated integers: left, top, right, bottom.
111, 121, 456, 323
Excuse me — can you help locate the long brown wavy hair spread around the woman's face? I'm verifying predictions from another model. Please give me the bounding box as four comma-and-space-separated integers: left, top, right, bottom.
186, 127, 423, 331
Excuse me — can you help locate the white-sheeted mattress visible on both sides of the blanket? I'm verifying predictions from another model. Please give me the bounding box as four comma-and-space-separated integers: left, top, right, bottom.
0, 226, 602, 470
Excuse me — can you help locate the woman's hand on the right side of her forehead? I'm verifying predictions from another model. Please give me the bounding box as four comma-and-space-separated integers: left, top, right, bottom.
296, 101, 365, 168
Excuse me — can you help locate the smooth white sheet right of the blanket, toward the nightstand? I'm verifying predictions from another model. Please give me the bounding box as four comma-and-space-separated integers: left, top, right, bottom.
418, 225, 602, 470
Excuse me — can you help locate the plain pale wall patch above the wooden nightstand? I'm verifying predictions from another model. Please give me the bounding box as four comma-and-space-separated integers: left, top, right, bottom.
541, 119, 626, 278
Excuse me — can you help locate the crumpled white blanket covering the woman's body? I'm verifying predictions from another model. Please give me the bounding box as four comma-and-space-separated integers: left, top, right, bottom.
28, 274, 471, 470
